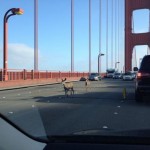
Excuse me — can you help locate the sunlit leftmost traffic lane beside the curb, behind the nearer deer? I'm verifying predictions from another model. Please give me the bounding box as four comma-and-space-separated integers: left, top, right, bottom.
0, 80, 134, 101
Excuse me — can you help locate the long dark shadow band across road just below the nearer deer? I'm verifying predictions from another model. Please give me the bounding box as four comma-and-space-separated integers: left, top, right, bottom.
34, 89, 129, 104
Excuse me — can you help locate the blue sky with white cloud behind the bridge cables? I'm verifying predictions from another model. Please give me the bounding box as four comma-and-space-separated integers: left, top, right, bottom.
0, 0, 149, 72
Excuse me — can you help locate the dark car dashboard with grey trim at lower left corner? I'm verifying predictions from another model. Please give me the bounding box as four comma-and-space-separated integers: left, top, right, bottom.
0, 117, 150, 150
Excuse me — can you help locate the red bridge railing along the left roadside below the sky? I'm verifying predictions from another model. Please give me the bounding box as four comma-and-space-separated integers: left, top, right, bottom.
0, 69, 89, 81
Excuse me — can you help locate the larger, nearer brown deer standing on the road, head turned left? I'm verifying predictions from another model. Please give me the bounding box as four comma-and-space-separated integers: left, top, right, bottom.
62, 78, 74, 97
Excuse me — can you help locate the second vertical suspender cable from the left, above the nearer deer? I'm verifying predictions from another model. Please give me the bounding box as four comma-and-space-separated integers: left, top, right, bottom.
71, 0, 74, 72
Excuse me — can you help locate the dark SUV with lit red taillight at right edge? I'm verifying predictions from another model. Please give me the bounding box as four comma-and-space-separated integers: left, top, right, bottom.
134, 55, 150, 102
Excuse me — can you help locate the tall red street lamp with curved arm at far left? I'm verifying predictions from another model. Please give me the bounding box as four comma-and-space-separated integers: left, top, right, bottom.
3, 8, 24, 81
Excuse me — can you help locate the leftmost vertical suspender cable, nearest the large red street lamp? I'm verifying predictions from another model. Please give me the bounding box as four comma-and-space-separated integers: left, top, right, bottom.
34, 0, 38, 71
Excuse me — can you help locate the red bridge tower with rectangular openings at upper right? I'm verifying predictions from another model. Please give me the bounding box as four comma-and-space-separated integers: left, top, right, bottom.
125, 0, 150, 71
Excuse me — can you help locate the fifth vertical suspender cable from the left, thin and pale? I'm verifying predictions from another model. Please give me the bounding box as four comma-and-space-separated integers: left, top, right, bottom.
106, 0, 108, 69
